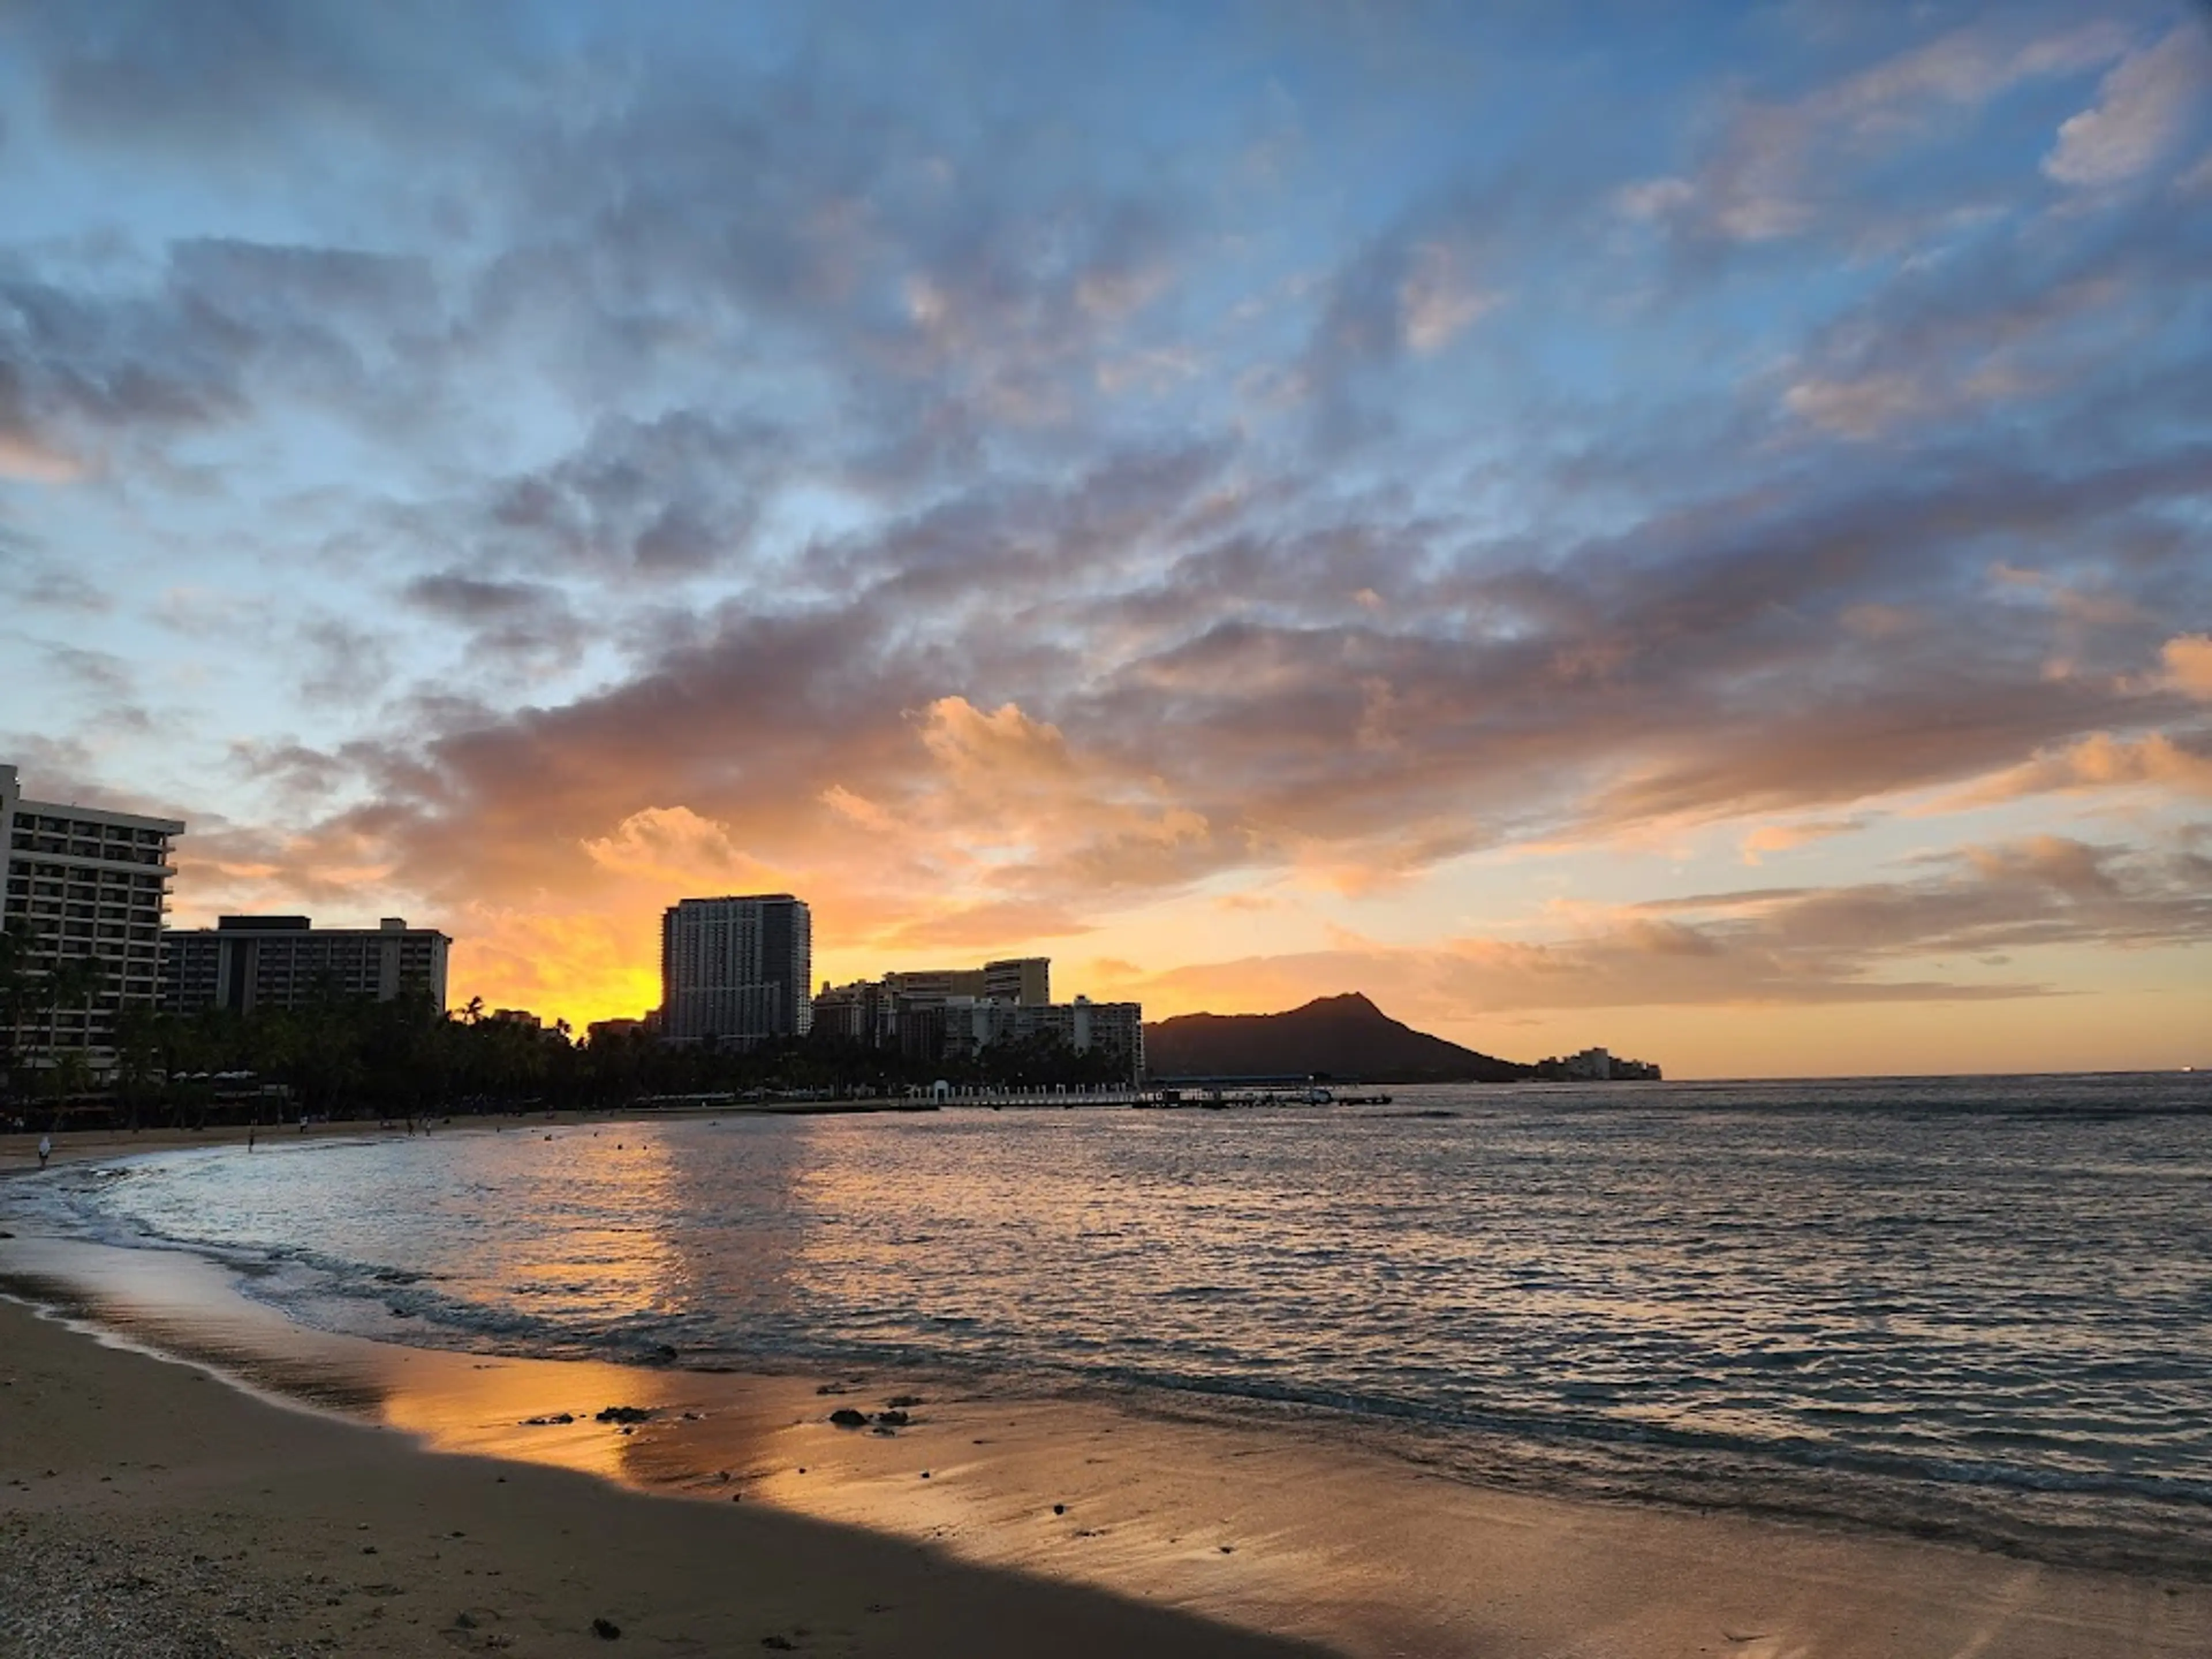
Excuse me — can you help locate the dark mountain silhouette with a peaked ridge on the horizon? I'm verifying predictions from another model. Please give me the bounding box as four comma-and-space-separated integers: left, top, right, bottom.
1143, 991, 1531, 1084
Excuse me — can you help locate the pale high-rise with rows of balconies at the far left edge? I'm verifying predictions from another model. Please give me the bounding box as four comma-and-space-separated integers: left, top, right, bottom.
0, 766, 184, 1069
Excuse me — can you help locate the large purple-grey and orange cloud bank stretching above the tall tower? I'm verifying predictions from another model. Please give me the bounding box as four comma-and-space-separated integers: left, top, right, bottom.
172, 422, 2205, 1022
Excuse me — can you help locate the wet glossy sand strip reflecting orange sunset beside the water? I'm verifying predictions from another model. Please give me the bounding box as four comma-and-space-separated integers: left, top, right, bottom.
0, 1238, 2212, 1659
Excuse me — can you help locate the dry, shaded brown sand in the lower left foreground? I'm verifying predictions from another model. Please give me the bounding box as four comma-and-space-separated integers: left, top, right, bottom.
0, 1305, 1327, 1659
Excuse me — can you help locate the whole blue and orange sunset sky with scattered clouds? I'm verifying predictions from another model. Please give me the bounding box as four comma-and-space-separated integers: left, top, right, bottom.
0, 0, 2212, 1075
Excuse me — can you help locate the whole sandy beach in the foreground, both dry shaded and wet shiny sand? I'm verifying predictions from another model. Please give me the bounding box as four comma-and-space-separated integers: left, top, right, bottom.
0, 1230, 2212, 1659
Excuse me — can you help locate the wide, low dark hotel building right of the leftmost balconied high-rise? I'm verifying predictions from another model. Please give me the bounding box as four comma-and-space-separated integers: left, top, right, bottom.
161, 916, 453, 1016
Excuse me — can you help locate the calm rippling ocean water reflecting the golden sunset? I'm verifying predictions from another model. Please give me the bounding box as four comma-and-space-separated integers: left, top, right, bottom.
0, 1075, 2212, 1575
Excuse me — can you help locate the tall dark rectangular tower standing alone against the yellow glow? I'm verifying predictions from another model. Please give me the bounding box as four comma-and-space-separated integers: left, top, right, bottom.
661, 893, 814, 1048
